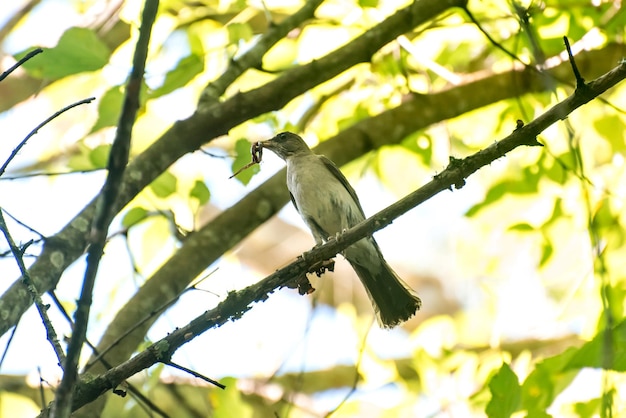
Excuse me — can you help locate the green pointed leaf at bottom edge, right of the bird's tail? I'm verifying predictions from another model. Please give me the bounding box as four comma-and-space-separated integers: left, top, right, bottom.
485, 363, 521, 418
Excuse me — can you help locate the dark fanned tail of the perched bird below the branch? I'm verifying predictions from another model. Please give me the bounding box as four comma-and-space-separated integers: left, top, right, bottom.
348, 256, 422, 328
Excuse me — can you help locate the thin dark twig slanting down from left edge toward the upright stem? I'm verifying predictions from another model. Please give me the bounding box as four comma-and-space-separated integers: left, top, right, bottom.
0, 212, 65, 367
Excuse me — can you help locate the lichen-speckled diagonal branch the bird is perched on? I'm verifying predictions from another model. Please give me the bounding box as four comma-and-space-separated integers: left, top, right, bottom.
40, 61, 626, 409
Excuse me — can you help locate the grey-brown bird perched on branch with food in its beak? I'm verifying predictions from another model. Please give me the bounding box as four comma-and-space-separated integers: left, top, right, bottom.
261, 132, 422, 328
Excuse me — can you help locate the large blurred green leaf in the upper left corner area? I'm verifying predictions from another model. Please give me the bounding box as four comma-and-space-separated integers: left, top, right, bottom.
15, 28, 111, 80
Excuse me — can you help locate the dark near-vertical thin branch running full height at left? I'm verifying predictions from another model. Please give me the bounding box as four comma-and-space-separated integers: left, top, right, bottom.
52, 0, 159, 418
